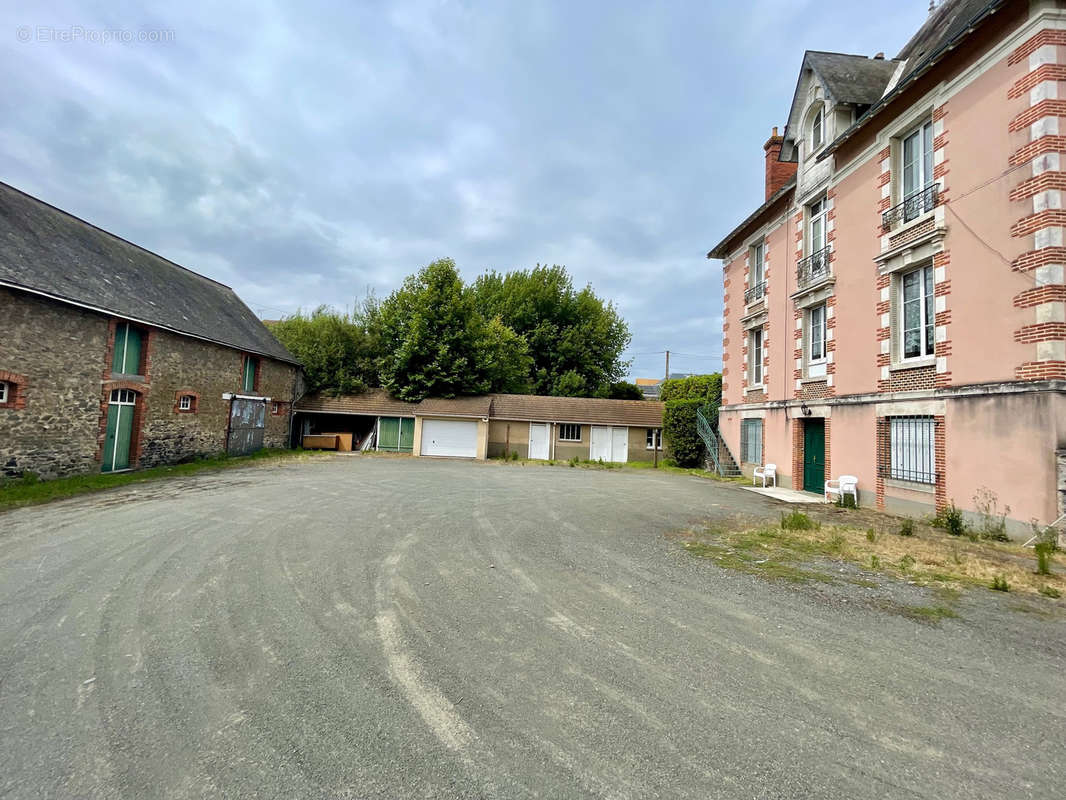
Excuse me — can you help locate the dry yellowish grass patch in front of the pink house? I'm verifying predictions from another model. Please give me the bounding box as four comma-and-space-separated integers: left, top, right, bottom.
685, 512, 1066, 606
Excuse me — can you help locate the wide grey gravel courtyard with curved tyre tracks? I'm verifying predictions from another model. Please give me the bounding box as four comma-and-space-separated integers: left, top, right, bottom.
0, 457, 1066, 800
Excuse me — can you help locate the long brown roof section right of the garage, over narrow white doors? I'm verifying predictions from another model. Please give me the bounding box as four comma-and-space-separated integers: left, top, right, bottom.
491, 395, 663, 428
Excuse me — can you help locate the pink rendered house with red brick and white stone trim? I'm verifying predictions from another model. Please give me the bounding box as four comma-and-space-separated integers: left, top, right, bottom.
708, 0, 1066, 535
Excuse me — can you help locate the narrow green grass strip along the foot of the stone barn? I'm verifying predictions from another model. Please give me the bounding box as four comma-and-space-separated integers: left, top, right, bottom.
0, 449, 321, 511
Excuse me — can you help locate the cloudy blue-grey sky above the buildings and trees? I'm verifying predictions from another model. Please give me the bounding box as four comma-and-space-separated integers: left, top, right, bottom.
0, 0, 927, 377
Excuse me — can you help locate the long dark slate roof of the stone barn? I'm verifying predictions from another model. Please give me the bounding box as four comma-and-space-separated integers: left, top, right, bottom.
0, 182, 298, 364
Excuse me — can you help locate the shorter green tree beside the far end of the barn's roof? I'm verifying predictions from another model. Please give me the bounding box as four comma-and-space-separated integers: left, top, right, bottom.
271, 305, 376, 394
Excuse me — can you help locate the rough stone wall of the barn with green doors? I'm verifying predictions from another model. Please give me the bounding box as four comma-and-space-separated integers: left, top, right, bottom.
0, 290, 296, 478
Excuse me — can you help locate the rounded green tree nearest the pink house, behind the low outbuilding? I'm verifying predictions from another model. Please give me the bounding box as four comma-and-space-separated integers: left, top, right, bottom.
472, 265, 631, 397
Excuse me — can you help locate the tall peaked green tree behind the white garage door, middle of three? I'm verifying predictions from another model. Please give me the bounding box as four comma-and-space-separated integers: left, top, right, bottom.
368, 258, 529, 400
